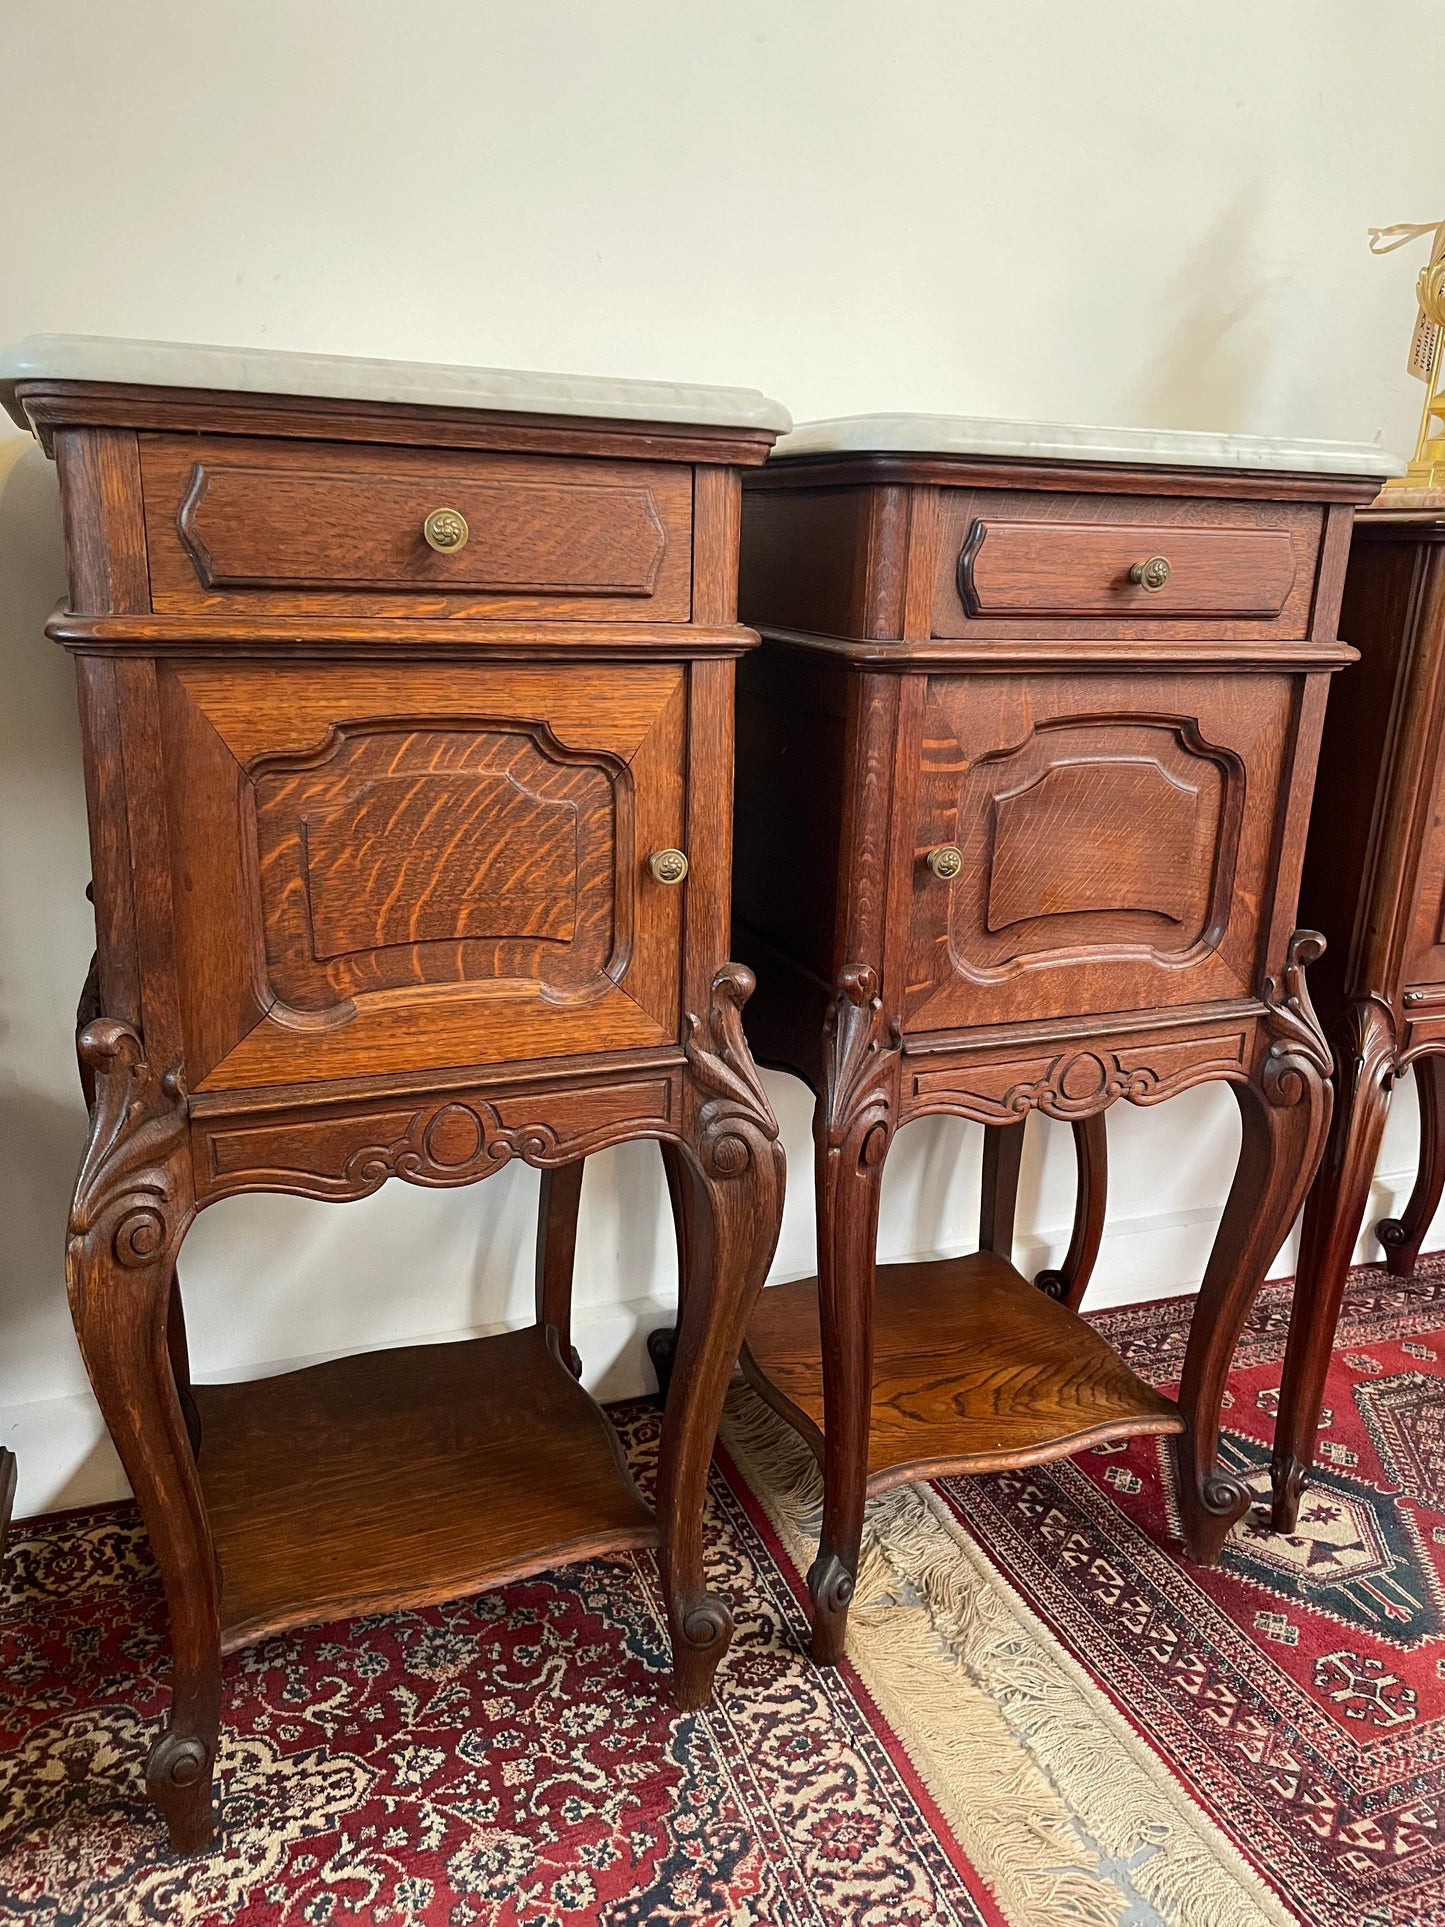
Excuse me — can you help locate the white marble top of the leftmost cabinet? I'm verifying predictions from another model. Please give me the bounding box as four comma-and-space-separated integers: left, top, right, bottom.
0, 335, 792, 430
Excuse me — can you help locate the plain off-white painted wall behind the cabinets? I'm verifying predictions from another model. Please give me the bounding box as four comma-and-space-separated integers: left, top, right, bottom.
0, 0, 1445, 1511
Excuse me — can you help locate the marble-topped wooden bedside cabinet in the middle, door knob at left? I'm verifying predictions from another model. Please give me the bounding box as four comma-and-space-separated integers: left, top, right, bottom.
734, 416, 1389, 1661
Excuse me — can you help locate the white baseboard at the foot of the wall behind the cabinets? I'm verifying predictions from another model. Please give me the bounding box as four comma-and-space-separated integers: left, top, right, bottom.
0, 1172, 1445, 1518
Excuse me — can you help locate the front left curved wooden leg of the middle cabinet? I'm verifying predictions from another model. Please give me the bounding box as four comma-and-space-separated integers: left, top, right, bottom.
807, 969, 901, 1665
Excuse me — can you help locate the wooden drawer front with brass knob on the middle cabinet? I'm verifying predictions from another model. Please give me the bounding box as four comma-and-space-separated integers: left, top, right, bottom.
933, 489, 1322, 640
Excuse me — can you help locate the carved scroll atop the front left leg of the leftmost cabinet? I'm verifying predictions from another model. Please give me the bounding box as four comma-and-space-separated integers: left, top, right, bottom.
69, 1017, 191, 1270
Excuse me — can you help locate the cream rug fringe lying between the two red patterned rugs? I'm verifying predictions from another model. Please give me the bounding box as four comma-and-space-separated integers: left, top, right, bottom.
726, 1393, 1291, 1927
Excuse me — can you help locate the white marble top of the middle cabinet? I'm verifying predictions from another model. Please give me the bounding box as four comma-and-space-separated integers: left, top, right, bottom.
773, 414, 1405, 476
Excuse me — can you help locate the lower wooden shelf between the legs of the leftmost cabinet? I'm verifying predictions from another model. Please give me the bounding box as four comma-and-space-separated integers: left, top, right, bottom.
195, 1328, 657, 1653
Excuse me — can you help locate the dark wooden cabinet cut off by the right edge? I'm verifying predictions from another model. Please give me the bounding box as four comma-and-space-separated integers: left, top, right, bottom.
1274, 509, 1445, 1532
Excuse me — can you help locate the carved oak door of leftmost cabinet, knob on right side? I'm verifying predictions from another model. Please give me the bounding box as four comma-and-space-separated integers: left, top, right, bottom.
160, 663, 686, 1089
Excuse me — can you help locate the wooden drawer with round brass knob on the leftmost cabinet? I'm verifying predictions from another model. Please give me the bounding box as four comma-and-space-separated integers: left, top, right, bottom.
141, 437, 692, 622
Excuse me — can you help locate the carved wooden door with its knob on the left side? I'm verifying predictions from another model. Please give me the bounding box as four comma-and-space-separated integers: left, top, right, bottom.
904, 673, 1295, 1031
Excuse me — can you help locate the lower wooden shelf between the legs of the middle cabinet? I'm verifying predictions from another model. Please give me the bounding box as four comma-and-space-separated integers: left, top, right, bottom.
744, 1251, 1185, 1493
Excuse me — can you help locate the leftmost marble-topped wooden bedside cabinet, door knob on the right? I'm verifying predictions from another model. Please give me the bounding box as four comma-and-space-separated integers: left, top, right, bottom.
0, 337, 786, 1850
